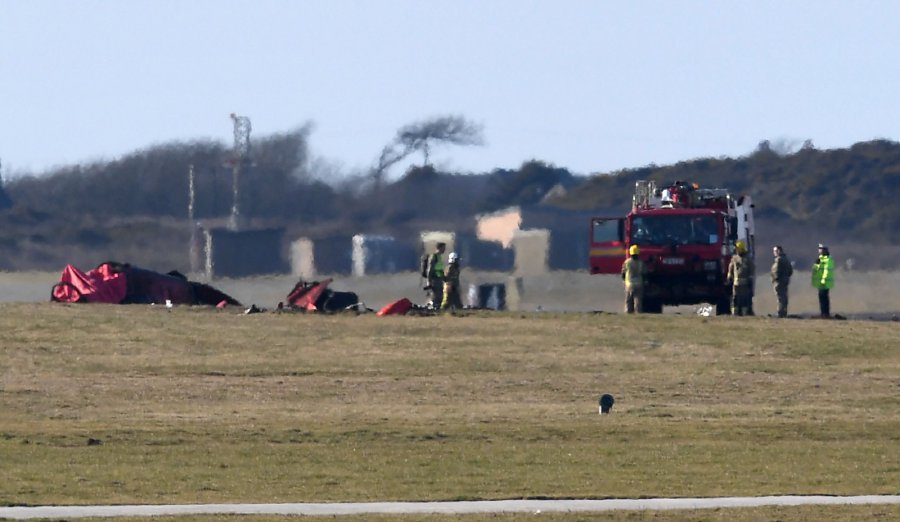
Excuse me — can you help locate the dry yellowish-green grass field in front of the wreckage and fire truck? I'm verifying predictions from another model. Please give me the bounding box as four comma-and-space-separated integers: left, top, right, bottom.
0, 303, 900, 520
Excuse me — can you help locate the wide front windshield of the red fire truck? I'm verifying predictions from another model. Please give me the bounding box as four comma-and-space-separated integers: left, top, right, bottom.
631, 215, 719, 245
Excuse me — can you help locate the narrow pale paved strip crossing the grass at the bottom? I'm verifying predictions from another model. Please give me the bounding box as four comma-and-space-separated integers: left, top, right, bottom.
0, 495, 900, 520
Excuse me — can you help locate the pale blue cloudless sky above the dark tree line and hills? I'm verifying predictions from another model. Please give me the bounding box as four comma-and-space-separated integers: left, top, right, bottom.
0, 0, 900, 177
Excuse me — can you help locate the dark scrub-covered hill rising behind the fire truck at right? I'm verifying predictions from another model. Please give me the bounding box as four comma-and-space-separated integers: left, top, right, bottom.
553, 140, 900, 268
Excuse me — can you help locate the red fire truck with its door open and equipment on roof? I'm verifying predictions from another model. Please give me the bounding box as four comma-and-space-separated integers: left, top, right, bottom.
590, 181, 755, 314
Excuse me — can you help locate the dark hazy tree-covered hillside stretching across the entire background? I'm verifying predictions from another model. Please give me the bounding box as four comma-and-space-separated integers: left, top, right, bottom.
0, 136, 900, 271
